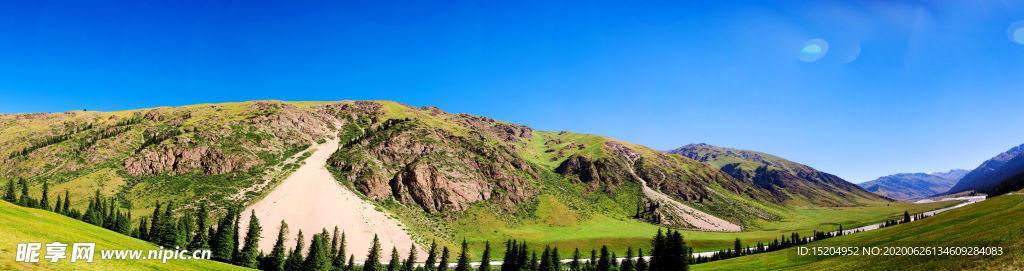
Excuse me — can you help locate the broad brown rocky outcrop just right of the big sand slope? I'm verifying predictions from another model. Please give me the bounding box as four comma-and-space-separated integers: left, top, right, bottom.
331, 120, 540, 213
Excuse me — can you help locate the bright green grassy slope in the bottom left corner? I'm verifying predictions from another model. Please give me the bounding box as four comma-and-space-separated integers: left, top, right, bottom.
0, 201, 246, 270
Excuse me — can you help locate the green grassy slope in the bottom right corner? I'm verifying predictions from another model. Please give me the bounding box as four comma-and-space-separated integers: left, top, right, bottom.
691, 194, 1024, 270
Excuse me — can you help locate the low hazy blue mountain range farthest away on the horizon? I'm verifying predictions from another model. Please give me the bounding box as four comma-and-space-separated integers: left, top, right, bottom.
860, 170, 970, 200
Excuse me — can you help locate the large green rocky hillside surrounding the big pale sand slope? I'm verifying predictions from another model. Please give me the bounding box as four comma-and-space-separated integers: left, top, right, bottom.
0, 101, 933, 257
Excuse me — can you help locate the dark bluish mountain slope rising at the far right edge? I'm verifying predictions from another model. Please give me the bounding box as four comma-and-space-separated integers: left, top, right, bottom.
947, 144, 1024, 193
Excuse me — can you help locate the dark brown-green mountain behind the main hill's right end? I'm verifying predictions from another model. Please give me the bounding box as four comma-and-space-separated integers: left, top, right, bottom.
668, 143, 884, 206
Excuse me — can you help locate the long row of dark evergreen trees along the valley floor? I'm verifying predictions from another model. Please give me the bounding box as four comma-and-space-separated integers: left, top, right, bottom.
3, 180, 926, 271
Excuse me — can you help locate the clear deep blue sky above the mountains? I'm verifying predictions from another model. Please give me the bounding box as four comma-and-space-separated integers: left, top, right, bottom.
0, 1, 1024, 182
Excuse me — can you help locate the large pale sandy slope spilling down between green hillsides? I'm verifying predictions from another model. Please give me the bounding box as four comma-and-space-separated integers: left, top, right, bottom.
240, 139, 425, 261
